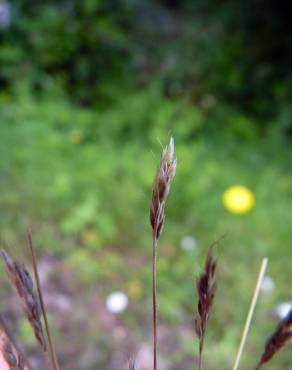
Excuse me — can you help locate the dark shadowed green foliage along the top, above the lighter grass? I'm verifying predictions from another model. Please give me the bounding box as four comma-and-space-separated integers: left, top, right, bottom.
0, 0, 291, 134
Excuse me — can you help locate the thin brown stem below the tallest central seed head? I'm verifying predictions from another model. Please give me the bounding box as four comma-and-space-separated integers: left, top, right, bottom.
152, 230, 157, 370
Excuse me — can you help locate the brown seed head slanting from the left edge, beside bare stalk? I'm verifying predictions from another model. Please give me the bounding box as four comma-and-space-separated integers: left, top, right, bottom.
0, 250, 47, 352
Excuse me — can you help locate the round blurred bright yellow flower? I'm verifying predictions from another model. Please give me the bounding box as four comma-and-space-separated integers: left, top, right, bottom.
222, 185, 255, 214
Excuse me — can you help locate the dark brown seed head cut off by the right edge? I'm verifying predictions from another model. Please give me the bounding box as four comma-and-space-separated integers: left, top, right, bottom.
256, 308, 292, 370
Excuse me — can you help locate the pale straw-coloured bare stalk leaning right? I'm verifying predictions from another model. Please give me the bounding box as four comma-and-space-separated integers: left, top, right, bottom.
233, 258, 268, 370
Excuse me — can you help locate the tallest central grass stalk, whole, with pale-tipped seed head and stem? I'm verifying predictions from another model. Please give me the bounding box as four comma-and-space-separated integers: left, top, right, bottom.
150, 138, 176, 370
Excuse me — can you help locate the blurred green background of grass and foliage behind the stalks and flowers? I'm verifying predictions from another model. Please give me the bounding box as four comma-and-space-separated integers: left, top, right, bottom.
0, 0, 292, 370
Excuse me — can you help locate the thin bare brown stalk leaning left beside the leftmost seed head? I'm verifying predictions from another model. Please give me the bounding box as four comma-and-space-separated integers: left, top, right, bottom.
27, 231, 60, 370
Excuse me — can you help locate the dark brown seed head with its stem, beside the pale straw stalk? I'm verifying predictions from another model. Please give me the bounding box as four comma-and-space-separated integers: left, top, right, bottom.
195, 246, 217, 370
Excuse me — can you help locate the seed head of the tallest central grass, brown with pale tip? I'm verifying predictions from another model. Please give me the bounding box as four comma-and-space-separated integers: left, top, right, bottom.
150, 138, 176, 240
